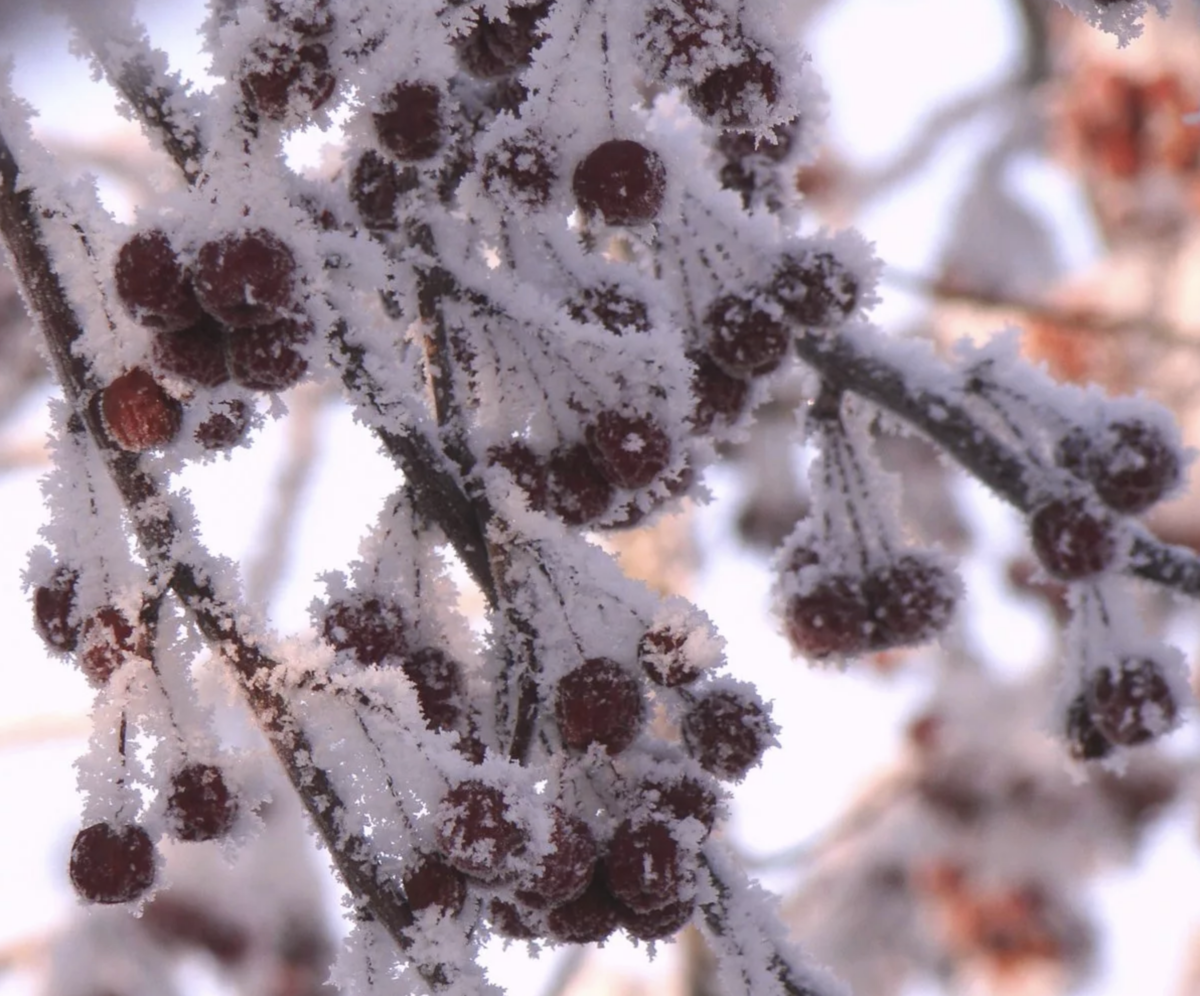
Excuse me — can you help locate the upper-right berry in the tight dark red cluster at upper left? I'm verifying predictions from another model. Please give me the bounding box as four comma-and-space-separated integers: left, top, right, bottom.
196, 228, 296, 329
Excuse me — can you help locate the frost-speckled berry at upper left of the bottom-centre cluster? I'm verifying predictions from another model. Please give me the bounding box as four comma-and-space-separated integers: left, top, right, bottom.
434, 781, 528, 882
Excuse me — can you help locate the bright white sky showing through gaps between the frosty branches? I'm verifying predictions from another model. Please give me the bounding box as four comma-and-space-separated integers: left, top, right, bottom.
0, 0, 1200, 996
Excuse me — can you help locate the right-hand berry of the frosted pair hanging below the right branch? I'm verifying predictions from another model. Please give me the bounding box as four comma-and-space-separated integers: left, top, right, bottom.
863, 553, 959, 650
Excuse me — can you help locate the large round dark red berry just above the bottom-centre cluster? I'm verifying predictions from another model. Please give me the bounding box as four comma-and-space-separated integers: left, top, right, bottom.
554, 658, 646, 754
